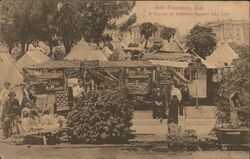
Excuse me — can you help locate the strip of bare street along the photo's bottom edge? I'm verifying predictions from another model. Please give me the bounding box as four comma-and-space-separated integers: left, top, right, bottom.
0, 144, 249, 159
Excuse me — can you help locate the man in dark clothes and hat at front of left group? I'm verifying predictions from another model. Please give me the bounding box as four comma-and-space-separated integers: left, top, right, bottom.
1, 91, 20, 138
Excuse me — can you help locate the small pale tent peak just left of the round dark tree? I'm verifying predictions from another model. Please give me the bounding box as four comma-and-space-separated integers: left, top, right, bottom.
160, 39, 185, 53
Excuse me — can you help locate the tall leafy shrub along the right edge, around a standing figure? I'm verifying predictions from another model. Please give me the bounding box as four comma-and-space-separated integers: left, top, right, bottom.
215, 42, 250, 126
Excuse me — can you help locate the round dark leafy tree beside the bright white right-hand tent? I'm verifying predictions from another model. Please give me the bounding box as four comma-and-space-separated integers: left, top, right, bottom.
186, 25, 216, 59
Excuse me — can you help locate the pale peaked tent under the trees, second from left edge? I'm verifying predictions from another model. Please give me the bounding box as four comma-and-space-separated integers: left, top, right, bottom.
16, 47, 51, 71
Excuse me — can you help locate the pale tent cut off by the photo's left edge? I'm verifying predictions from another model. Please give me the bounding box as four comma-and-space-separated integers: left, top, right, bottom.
0, 52, 23, 89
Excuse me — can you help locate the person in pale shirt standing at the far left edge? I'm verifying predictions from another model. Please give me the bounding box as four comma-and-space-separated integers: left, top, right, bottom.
0, 81, 10, 129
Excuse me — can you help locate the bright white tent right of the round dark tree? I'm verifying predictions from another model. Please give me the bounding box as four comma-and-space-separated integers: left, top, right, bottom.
205, 43, 238, 67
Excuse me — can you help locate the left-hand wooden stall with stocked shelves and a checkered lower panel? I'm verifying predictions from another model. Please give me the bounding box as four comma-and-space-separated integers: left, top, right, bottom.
24, 61, 80, 113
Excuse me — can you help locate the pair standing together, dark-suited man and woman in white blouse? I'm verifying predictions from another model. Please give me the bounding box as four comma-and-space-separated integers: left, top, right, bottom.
152, 84, 182, 124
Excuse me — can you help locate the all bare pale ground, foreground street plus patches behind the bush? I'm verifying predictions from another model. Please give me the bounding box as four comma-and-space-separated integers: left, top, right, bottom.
0, 111, 249, 159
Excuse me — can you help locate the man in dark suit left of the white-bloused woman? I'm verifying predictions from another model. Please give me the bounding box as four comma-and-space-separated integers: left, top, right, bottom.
152, 87, 165, 119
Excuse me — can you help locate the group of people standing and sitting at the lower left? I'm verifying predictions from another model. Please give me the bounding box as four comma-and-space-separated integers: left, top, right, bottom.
0, 82, 65, 138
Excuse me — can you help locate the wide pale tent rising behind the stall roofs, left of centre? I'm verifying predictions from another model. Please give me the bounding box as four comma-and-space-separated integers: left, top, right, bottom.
64, 40, 108, 61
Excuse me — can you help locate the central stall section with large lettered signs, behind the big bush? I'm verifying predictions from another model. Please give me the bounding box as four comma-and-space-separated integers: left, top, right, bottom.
99, 61, 155, 96
